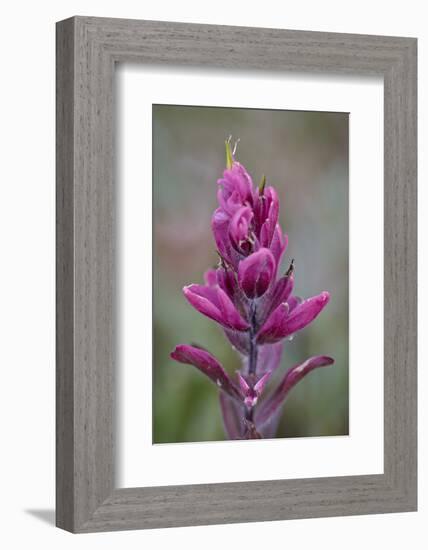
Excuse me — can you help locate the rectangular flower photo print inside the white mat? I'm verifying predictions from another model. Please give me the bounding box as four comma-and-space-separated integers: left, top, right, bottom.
152, 105, 349, 444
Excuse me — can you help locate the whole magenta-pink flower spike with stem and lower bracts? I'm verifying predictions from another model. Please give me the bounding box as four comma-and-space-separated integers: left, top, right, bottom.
171, 140, 334, 439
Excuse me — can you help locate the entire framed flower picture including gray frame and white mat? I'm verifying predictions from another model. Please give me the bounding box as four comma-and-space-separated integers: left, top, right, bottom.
57, 17, 417, 533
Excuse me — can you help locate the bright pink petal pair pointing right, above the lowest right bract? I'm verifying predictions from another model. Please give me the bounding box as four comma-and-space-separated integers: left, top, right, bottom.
258, 292, 330, 344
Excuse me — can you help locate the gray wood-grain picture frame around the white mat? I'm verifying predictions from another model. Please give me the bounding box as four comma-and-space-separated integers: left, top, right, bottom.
56, 17, 417, 532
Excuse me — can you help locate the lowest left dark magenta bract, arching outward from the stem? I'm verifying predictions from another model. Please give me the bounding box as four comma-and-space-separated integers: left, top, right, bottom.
171, 344, 241, 400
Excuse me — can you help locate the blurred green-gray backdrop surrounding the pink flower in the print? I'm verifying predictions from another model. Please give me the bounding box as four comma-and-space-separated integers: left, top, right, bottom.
153, 105, 348, 443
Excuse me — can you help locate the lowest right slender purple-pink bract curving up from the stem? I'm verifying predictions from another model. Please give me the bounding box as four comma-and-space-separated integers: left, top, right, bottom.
256, 355, 334, 426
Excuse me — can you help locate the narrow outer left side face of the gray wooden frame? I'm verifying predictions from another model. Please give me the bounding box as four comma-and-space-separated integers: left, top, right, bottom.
56, 18, 75, 530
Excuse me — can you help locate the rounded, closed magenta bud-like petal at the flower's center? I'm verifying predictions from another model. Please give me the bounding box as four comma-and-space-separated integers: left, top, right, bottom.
238, 248, 276, 299
